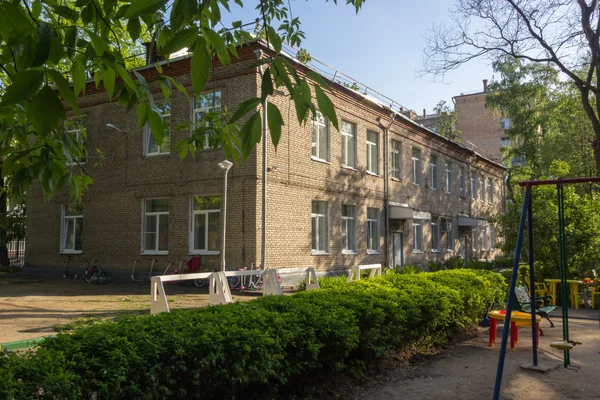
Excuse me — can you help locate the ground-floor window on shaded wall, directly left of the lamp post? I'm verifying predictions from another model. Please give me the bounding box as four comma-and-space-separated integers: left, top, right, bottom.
190, 196, 221, 254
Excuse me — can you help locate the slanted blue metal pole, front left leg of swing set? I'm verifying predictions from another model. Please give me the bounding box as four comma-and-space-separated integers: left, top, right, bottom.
494, 186, 531, 400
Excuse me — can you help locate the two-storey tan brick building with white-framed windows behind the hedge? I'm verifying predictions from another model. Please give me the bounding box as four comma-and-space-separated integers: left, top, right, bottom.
25, 41, 504, 270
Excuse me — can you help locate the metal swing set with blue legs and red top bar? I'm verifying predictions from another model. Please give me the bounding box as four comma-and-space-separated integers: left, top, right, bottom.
494, 177, 600, 400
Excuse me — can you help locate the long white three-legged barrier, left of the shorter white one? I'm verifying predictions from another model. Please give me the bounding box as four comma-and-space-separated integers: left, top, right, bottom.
150, 269, 282, 314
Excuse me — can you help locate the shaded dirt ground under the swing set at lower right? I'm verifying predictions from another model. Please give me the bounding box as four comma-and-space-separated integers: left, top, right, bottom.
356, 309, 600, 400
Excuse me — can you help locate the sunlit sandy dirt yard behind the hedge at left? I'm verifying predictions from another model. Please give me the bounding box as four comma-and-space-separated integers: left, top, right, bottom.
0, 273, 254, 343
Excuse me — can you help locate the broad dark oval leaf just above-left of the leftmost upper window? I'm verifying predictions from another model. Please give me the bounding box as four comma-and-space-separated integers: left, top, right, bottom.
27, 86, 65, 134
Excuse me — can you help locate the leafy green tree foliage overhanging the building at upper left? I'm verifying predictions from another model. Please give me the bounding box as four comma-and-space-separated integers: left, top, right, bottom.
0, 0, 364, 200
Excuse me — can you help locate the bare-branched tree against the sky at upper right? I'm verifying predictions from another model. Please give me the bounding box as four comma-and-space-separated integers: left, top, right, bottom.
424, 0, 600, 173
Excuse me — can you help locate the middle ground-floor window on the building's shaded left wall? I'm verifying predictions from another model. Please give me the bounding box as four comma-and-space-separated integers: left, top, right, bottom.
142, 199, 169, 254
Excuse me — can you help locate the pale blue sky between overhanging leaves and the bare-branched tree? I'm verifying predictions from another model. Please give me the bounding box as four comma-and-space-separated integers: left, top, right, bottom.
224, 0, 493, 114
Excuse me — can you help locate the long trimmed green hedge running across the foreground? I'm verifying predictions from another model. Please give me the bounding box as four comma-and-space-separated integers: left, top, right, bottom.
0, 270, 505, 399
